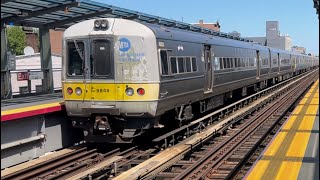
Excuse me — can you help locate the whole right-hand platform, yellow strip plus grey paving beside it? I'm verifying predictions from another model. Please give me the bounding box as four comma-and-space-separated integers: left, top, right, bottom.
244, 79, 319, 180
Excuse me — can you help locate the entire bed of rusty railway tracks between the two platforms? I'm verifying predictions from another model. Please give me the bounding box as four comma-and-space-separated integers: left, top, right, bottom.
1, 69, 318, 179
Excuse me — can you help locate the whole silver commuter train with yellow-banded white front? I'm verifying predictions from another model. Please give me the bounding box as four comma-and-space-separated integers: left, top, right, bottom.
62, 18, 318, 142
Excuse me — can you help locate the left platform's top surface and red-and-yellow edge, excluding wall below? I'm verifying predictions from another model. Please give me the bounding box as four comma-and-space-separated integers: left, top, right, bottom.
1, 93, 64, 122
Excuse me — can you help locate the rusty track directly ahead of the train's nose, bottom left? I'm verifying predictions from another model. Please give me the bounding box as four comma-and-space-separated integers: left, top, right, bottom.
1, 145, 156, 180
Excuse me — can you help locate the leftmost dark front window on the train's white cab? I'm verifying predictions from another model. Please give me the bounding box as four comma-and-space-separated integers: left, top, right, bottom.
67, 40, 85, 76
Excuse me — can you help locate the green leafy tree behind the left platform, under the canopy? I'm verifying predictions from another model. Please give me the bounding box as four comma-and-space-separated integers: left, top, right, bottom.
7, 26, 27, 55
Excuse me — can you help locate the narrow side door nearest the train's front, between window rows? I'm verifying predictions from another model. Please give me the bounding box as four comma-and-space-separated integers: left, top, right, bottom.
203, 45, 213, 92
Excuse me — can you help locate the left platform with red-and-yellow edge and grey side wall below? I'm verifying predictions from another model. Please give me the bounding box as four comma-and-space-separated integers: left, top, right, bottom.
1, 92, 83, 169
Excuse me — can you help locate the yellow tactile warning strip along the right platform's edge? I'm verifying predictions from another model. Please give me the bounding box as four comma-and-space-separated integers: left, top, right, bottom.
245, 79, 319, 180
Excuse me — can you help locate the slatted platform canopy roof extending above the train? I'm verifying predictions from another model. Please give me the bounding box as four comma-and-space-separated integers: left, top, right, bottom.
1, 0, 248, 41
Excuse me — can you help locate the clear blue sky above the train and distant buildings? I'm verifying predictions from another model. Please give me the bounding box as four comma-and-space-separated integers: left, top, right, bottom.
95, 0, 319, 54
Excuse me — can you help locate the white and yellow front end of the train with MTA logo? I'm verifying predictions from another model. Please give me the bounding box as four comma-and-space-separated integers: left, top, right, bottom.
62, 19, 159, 142
